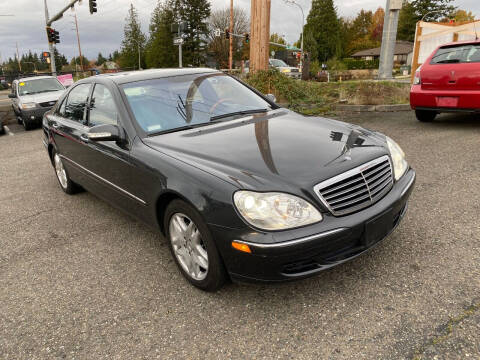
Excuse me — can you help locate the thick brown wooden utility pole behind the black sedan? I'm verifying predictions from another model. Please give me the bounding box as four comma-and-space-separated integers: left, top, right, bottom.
250, 0, 271, 71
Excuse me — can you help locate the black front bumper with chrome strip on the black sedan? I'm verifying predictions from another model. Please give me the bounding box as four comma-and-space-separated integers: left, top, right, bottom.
210, 169, 415, 282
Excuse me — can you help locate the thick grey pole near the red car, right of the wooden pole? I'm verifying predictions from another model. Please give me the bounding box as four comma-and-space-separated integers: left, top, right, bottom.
378, 0, 403, 79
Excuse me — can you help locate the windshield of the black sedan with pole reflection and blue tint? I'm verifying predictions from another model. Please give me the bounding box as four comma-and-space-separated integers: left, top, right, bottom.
122, 73, 271, 134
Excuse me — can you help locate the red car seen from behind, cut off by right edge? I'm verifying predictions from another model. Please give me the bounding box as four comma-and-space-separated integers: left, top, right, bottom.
410, 40, 480, 121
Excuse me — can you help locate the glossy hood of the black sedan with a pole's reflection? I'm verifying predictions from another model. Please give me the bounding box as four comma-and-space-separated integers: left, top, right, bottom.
143, 109, 388, 193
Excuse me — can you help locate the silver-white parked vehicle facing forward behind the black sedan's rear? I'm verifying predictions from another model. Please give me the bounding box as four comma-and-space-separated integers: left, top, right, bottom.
8, 76, 65, 130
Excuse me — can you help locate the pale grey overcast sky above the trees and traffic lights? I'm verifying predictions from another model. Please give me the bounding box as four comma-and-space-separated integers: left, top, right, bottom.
0, 0, 480, 62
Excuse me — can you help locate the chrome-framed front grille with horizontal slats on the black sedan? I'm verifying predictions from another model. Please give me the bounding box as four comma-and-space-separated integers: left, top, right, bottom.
314, 156, 393, 216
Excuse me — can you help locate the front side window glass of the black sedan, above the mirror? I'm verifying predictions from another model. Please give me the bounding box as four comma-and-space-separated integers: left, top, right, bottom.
88, 84, 117, 126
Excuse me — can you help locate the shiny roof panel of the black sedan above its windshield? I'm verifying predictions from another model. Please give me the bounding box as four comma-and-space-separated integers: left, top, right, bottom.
86, 68, 220, 84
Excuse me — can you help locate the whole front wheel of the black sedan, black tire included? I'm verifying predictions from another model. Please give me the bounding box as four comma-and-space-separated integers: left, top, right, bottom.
163, 200, 227, 291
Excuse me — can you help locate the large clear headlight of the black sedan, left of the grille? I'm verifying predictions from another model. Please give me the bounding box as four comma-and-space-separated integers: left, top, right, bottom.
233, 191, 323, 230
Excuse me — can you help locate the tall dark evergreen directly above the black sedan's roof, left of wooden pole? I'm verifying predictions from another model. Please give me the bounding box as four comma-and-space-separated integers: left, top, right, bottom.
175, 0, 210, 66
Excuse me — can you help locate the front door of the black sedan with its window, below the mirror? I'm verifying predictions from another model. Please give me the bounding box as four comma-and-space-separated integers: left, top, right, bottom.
82, 83, 146, 213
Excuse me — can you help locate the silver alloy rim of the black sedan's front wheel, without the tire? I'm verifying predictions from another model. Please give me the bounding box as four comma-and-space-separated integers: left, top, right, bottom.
169, 213, 208, 281
